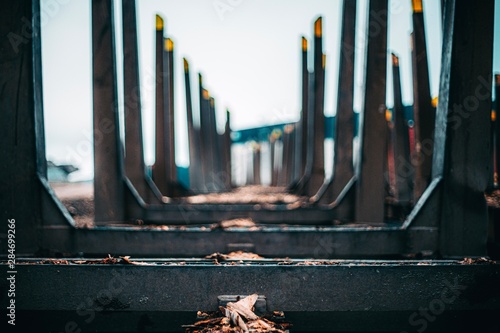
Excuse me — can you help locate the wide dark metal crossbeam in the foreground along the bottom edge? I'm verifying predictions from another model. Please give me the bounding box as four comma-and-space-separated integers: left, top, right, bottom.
8, 259, 500, 332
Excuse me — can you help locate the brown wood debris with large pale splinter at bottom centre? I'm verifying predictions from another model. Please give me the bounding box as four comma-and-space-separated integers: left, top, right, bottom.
182, 294, 291, 333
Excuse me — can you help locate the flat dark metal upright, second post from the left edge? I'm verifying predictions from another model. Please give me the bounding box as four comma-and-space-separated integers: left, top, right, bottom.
92, 0, 125, 223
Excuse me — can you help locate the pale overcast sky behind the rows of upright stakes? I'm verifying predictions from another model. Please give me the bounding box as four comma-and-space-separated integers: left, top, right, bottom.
41, 0, 500, 182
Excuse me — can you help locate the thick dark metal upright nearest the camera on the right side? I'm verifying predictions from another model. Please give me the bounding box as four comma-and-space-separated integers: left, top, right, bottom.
433, 0, 494, 257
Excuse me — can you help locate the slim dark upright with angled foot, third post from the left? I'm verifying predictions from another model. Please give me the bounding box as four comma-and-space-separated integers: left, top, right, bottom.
122, 0, 161, 203
